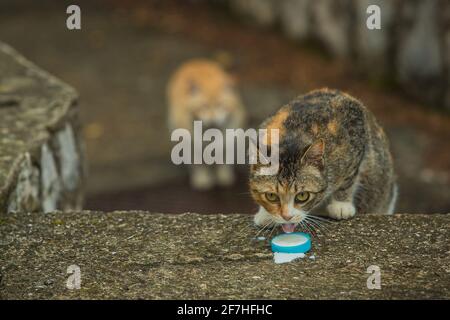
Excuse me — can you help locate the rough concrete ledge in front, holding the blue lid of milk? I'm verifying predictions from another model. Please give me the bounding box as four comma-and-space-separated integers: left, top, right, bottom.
0, 212, 450, 299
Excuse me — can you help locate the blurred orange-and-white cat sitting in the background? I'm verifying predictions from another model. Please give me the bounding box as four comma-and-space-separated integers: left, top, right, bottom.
167, 59, 245, 190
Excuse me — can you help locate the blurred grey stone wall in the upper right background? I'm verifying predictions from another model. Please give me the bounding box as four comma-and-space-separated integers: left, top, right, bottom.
227, 0, 450, 111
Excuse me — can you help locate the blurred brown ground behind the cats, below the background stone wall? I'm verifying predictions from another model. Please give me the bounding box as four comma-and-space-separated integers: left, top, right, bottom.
0, 0, 450, 213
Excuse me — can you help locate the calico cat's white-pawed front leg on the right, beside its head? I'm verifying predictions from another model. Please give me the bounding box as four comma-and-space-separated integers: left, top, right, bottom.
327, 182, 357, 220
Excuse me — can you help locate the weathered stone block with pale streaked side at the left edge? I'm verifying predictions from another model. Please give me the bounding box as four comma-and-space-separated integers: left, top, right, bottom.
0, 43, 85, 212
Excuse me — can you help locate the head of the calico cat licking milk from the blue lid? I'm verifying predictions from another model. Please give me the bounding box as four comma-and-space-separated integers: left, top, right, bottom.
250, 139, 327, 224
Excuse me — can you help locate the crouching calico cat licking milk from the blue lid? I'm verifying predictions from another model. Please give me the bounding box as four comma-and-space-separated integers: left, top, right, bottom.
250, 89, 397, 232
